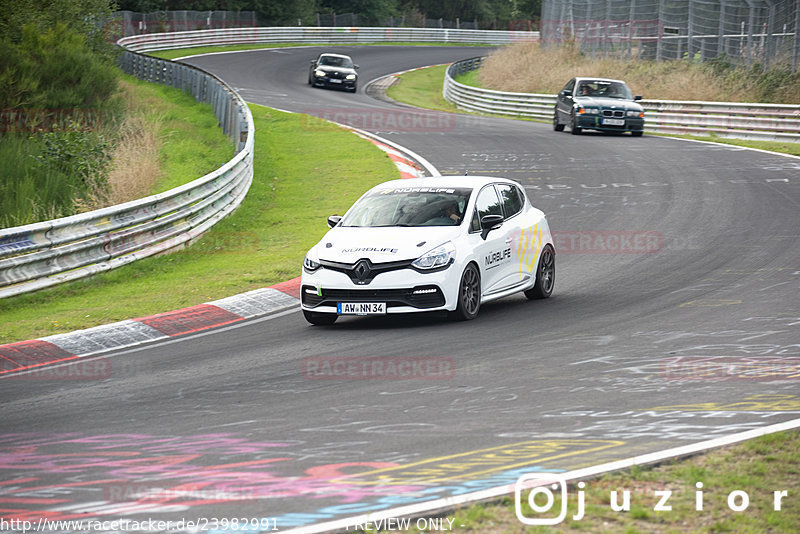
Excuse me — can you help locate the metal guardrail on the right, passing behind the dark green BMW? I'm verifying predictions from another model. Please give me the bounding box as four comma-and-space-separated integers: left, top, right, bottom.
442, 57, 800, 143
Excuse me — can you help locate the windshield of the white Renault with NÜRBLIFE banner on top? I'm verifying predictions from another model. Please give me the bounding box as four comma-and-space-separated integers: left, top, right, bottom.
342, 187, 472, 227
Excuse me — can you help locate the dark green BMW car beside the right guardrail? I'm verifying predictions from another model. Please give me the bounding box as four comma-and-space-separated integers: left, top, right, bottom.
553, 78, 644, 137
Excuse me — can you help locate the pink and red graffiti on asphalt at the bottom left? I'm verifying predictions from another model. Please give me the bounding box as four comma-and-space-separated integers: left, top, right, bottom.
0, 433, 422, 519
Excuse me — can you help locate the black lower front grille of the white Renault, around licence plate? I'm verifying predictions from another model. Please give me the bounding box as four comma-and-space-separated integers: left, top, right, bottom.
301, 286, 444, 309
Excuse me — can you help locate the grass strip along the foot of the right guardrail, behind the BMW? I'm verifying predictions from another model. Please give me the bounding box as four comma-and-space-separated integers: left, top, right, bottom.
386, 65, 800, 156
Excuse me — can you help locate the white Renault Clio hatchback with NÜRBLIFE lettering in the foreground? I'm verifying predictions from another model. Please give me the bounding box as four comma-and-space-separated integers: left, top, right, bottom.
301, 176, 555, 325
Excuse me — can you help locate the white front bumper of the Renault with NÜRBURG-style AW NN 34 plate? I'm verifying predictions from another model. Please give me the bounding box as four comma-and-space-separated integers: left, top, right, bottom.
300, 265, 458, 314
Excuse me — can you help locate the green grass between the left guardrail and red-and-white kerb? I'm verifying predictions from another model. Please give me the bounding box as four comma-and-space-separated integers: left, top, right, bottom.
0, 105, 397, 343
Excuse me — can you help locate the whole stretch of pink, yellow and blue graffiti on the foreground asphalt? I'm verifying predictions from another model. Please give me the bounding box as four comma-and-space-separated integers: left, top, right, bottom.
0, 433, 624, 528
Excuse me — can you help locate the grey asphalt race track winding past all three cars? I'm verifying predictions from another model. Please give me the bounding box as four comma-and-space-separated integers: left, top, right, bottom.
0, 46, 800, 531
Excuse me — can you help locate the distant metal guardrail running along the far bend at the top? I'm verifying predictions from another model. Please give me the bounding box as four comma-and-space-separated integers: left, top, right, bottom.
119, 26, 539, 52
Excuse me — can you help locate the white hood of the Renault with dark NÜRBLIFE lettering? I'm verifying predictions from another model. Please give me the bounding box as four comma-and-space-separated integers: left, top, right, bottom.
315, 226, 461, 263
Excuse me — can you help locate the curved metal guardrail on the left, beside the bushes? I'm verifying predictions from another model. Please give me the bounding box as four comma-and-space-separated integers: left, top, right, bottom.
0, 50, 253, 298
